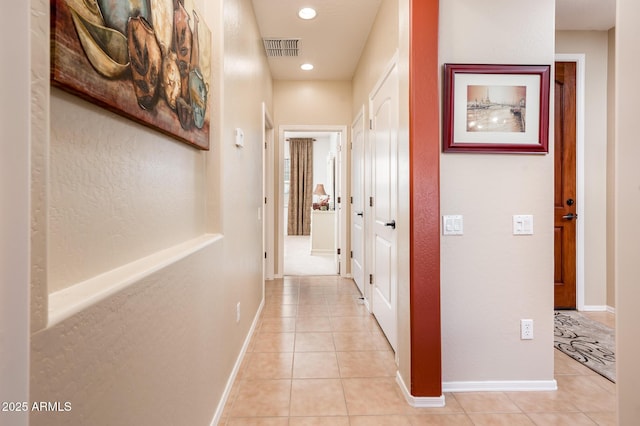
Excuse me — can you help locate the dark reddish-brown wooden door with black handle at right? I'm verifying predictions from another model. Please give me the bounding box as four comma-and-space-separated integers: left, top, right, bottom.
554, 62, 580, 309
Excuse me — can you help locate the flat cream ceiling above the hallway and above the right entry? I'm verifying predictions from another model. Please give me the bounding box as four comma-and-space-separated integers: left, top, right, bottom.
252, 0, 616, 80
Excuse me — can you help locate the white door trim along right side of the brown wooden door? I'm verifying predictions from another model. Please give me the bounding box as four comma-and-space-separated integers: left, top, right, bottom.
555, 53, 586, 311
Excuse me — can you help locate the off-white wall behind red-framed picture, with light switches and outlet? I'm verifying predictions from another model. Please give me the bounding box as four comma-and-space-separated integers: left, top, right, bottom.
440, 0, 555, 390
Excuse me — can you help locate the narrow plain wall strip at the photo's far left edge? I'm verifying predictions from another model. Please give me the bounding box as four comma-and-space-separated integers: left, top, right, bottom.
0, 2, 31, 426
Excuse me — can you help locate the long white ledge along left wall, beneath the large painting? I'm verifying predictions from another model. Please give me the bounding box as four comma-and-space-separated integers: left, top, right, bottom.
47, 234, 222, 327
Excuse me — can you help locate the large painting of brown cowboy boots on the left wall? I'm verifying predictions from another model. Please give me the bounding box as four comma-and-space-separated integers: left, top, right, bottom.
50, 0, 211, 150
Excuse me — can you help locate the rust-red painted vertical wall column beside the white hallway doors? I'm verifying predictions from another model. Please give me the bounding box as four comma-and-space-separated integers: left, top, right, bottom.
409, 0, 442, 397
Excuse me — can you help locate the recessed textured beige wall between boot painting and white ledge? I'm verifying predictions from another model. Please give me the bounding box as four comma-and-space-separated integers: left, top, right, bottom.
48, 89, 206, 292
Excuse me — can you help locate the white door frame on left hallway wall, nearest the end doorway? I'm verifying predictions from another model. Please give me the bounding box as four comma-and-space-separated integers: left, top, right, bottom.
262, 102, 277, 280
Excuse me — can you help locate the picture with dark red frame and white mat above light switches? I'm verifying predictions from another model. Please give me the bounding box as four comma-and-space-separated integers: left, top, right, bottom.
443, 64, 550, 154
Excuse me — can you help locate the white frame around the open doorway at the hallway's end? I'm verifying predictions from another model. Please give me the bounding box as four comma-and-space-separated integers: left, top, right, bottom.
276, 124, 349, 278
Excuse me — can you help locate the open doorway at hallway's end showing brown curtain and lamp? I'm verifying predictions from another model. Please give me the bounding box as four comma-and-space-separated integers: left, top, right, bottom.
282, 131, 341, 275
